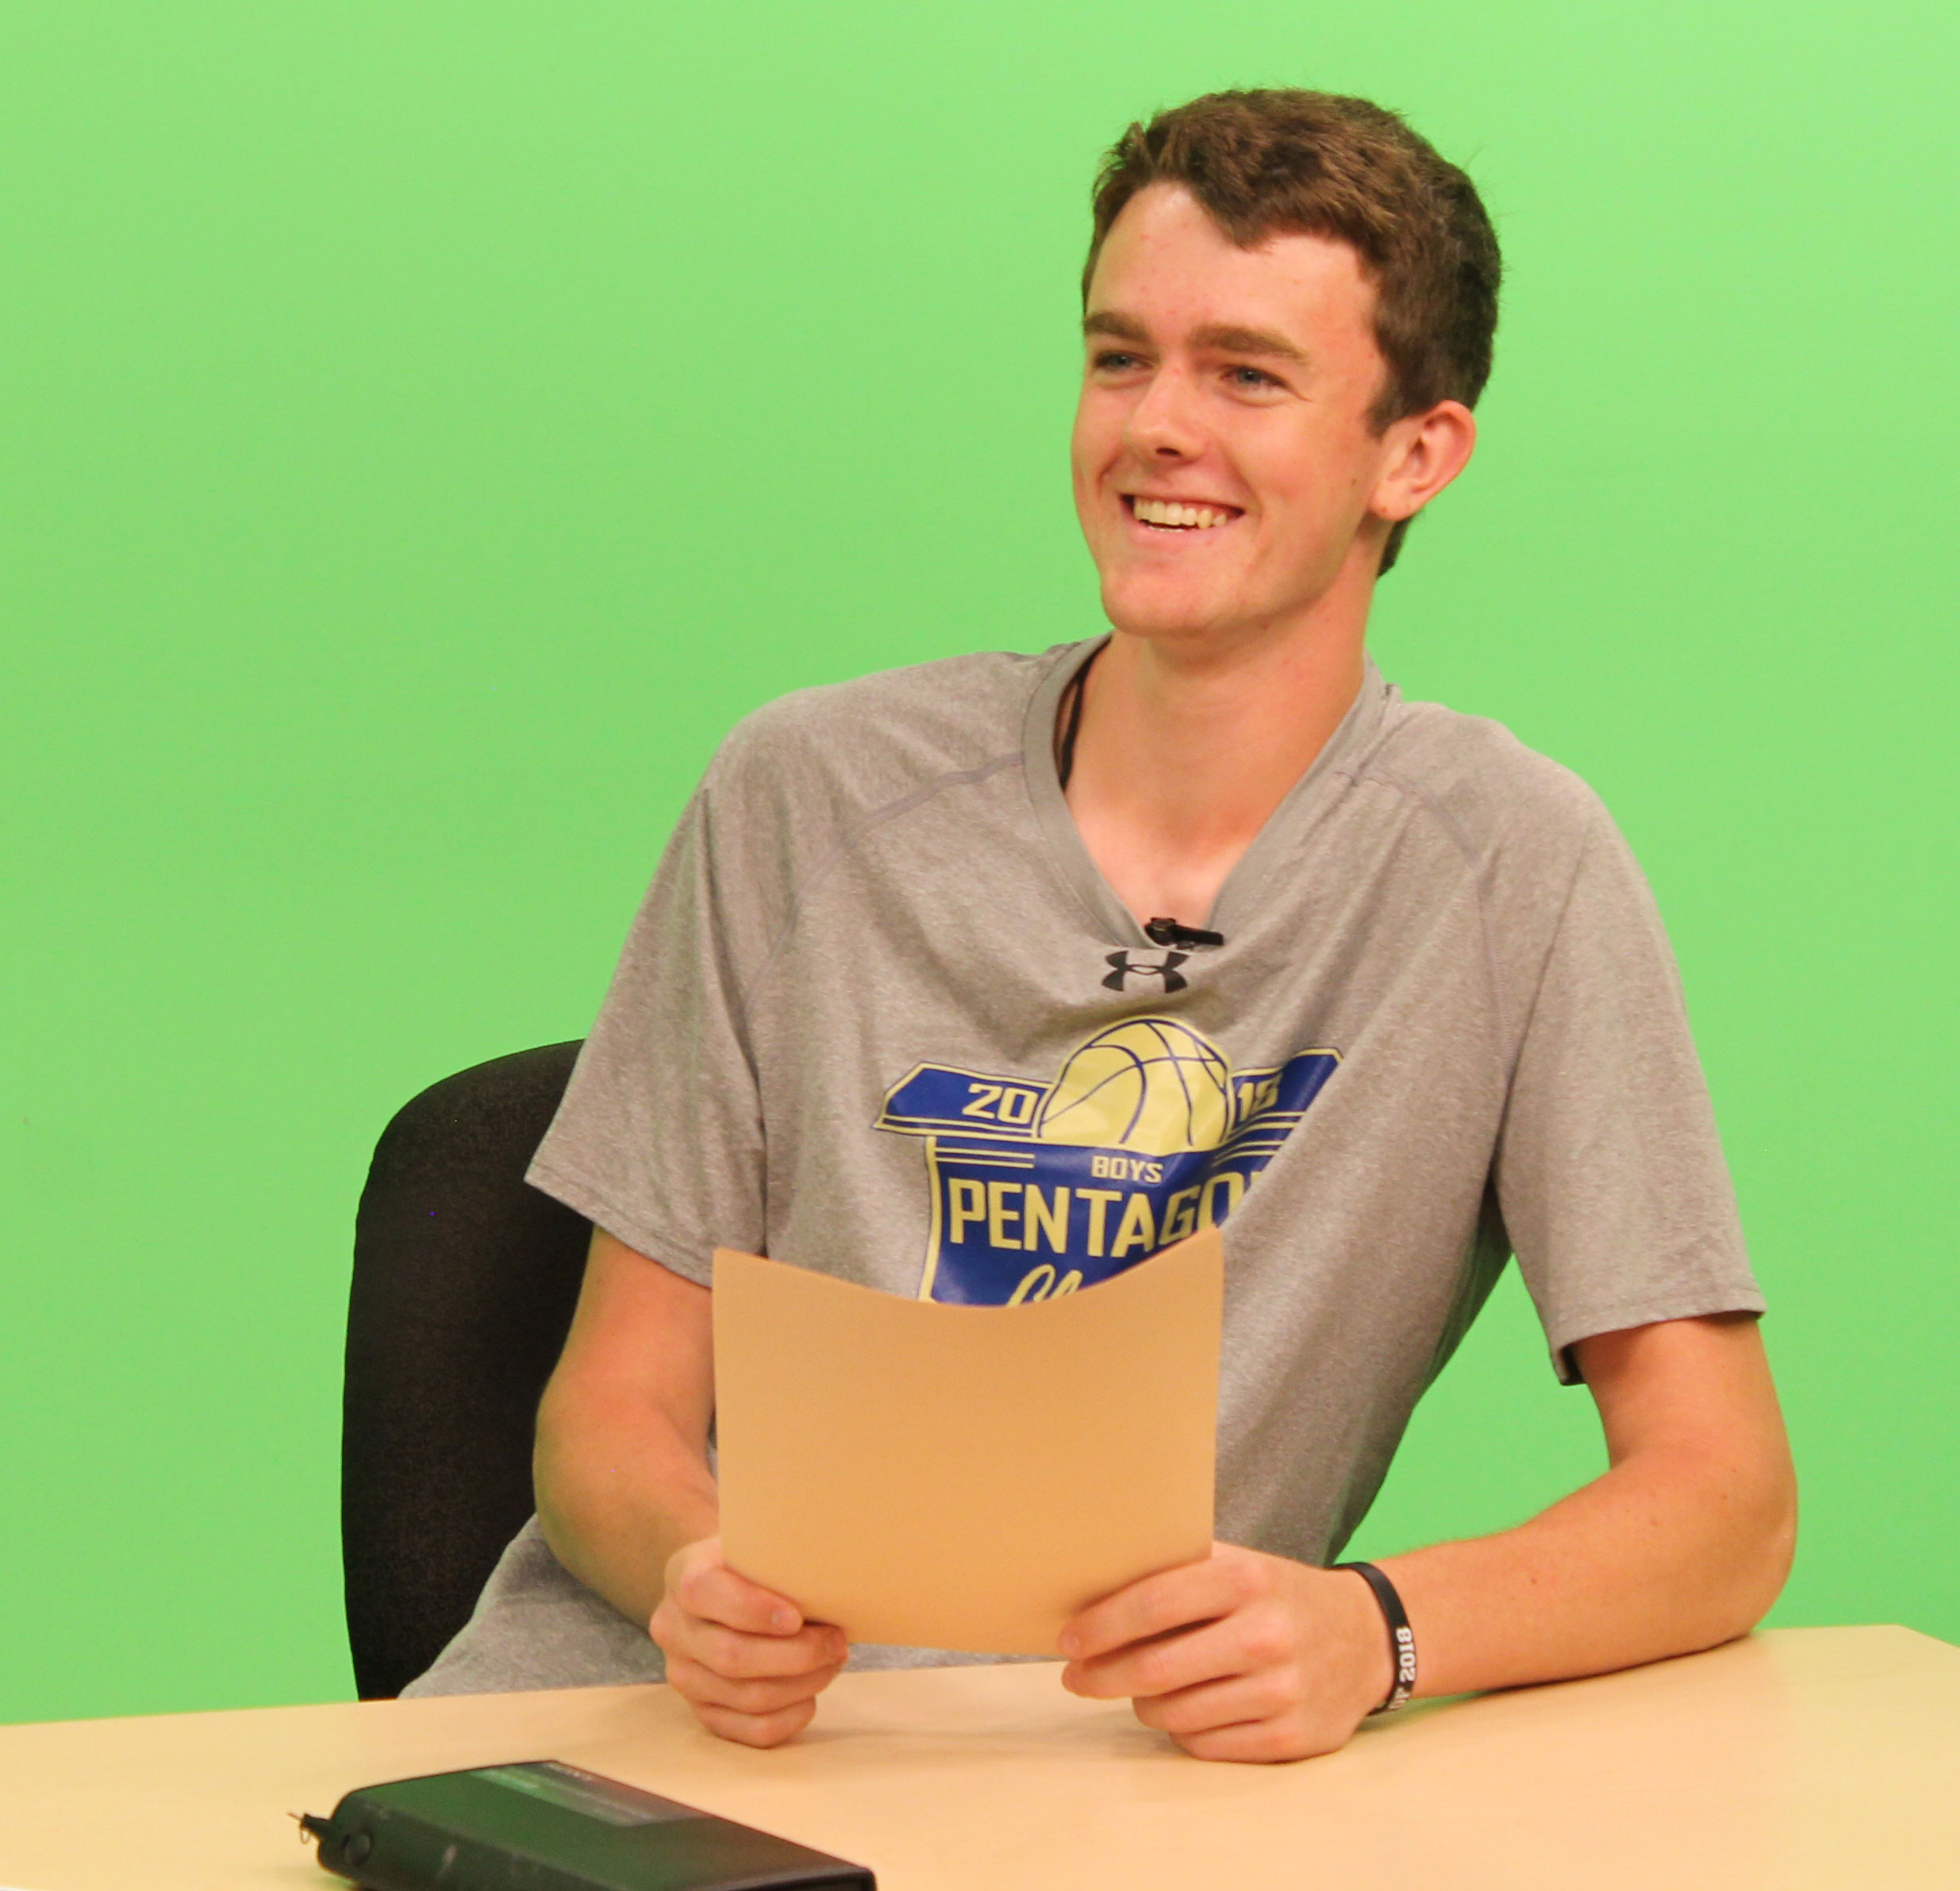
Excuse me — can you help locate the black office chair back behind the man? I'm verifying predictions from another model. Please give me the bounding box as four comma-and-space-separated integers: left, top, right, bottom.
341, 1043, 592, 1701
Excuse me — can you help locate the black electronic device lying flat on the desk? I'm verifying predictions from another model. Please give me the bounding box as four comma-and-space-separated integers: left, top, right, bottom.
300, 1760, 878, 1891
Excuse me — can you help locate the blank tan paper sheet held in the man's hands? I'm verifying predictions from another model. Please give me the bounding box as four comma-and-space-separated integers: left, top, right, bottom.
713, 1228, 1225, 1656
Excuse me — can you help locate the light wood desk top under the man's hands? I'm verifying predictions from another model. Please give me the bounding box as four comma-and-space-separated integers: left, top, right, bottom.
0, 1628, 1960, 1891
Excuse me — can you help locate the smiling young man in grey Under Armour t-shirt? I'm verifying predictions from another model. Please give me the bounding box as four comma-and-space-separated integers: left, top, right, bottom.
416, 92, 1793, 1760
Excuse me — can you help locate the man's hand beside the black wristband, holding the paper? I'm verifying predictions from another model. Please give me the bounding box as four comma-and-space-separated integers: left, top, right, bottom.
1060, 1542, 1392, 1760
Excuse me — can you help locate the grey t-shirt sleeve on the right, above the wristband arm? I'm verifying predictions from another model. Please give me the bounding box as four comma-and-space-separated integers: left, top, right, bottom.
1496, 803, 1764, 1383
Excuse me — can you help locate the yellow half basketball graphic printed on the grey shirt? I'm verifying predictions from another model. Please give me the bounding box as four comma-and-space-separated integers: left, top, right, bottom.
1035, 1017, 1231, 1156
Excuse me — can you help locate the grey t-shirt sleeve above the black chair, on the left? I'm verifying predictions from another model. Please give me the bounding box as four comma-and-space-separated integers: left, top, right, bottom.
527, 784, 764, 1286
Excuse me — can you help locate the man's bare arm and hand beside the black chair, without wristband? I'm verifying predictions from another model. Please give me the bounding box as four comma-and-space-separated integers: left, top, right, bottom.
533, 1228, 849, 1746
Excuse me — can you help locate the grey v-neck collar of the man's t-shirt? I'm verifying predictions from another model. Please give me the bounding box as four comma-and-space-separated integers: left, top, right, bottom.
1021, 635, 1389, 951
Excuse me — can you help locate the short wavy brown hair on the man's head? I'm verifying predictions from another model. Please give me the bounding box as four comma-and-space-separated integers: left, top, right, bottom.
1082, 90, 1503, 572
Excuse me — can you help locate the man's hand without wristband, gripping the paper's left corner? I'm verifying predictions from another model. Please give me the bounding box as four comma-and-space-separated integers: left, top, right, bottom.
647, 1536, 851, 1746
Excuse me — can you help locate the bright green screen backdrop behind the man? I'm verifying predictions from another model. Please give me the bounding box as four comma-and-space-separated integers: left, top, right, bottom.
0, 0, 1960, 1719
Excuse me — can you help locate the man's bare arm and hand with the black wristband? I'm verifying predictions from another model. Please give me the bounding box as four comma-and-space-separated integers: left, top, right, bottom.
1063, 1316, 1796, 1760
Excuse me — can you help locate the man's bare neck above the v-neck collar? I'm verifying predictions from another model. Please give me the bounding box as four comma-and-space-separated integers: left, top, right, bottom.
1068, 603, 1364, 925
